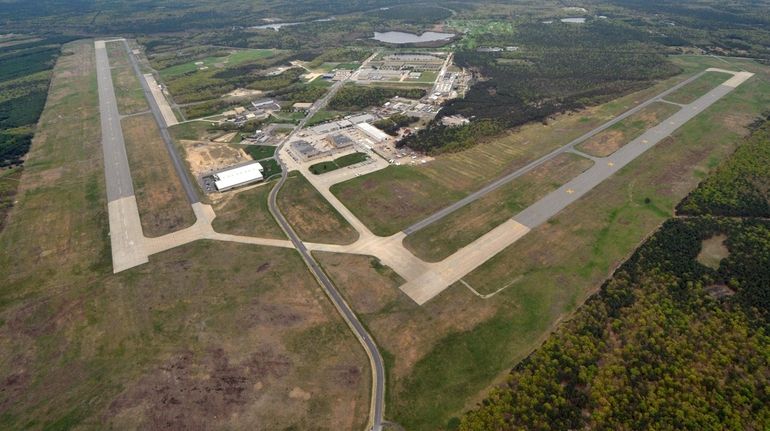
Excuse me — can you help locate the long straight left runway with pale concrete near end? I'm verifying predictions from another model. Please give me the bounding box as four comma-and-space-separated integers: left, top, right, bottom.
94, 40, 148, 272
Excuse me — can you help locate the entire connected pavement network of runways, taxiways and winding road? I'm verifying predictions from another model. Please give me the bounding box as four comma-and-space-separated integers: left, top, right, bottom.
95, 36, 752, 430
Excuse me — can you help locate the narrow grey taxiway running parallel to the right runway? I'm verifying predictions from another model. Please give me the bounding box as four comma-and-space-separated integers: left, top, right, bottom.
403, 71, 706, 235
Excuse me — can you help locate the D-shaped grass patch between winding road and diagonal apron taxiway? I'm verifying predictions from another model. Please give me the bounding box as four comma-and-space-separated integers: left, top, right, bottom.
277, 172, 358, 244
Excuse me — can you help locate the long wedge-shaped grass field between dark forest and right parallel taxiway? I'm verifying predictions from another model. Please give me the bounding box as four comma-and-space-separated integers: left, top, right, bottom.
332, 68, 703, 235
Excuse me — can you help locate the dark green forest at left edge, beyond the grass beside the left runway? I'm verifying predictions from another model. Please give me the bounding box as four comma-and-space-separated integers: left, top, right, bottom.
0, 37, 69, 168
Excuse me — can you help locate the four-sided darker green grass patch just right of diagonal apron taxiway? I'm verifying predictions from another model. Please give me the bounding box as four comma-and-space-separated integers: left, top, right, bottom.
331, 166, 465, 236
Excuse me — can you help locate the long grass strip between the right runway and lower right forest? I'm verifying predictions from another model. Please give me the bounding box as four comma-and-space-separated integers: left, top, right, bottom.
388, 57, 770, 431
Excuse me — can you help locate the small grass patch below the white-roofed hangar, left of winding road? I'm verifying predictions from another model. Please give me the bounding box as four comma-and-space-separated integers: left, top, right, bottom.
212, 183, 286, 239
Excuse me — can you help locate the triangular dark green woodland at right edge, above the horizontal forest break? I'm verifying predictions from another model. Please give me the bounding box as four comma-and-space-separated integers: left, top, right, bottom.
677, 117, 770, 217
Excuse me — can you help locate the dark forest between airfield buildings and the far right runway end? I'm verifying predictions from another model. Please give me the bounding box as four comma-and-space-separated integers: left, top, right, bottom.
399, 20, 678, 153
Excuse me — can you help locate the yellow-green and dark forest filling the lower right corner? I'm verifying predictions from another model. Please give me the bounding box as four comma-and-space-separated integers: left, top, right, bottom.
452, 119, 770, 431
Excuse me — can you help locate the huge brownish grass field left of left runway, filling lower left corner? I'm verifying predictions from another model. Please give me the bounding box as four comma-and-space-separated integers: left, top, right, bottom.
0, 41, 371, 430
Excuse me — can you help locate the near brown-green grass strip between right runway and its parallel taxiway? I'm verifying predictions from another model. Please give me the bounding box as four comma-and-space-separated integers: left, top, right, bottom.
404, 153, 593, 262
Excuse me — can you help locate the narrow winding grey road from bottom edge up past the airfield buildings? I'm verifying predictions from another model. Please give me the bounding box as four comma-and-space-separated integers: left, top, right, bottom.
268, 77, 385, 431
